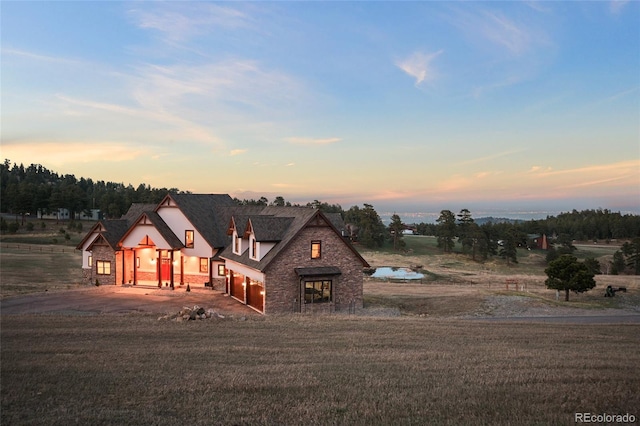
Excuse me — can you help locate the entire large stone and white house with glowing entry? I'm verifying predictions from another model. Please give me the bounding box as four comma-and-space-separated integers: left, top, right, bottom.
77, 194, 368, 313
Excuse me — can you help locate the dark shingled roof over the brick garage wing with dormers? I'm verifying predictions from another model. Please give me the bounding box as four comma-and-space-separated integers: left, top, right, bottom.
220, 206, 369, 271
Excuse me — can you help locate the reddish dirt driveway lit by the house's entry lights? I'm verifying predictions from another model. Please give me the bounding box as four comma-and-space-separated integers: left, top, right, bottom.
0, 286, 260, 317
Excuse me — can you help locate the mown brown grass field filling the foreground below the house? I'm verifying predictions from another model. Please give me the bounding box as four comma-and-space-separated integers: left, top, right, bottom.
1, 315, 640, 425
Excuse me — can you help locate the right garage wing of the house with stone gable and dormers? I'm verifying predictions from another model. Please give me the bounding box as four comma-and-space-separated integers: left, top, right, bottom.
220, 207, 369, 313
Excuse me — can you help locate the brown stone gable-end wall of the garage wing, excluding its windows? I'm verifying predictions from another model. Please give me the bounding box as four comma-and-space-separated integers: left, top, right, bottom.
264, 226, 363, 314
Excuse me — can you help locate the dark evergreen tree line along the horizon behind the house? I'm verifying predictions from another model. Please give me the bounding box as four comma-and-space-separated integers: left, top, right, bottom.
0, 160, 640, 273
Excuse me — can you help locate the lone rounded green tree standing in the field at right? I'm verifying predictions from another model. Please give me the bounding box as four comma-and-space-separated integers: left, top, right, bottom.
544, 254, 596, 302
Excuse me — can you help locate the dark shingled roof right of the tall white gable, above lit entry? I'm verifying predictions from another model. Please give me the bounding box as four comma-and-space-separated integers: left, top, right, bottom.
156, 194, 237, 248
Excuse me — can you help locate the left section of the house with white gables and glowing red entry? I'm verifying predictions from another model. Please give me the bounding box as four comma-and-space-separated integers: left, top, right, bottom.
77, 194, 235, 288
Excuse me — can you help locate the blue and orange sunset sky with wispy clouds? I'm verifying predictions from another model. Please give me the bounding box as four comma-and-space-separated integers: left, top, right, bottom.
0, 1, 640, 218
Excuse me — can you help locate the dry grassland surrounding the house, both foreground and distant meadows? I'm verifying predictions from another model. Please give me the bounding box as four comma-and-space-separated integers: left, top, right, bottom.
0, 237, 640, 425
